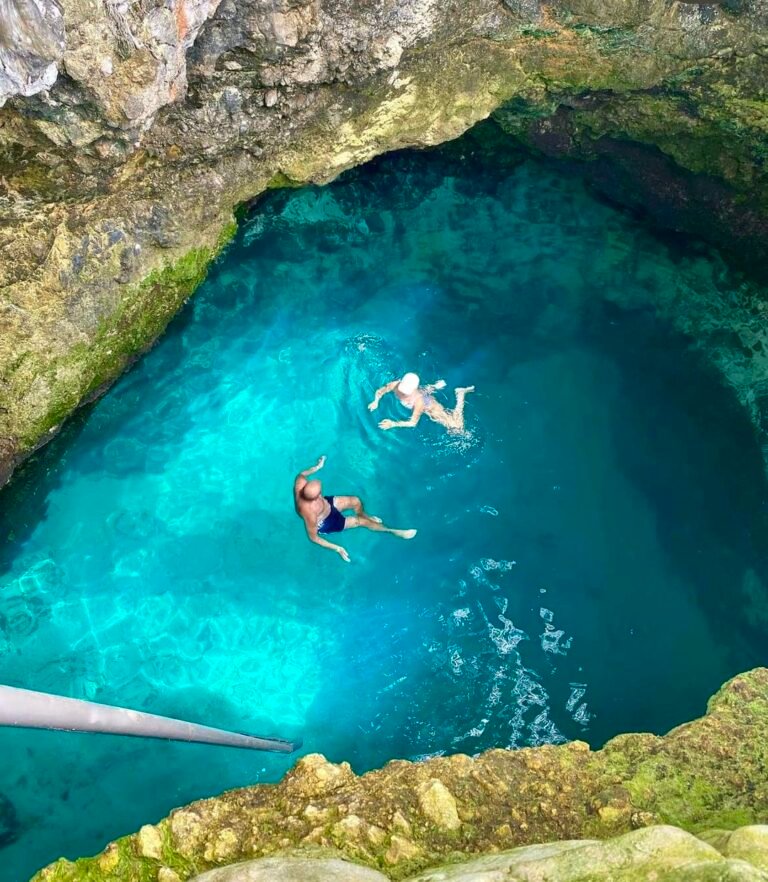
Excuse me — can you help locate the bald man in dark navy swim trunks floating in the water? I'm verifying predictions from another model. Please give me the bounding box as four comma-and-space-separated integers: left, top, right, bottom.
293, 456, 416, 563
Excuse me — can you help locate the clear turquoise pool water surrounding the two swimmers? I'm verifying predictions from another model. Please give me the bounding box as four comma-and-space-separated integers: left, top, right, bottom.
0, 145, 768, 880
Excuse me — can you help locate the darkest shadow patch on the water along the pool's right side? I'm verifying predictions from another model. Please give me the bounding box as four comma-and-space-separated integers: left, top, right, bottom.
587, 301, 768, 660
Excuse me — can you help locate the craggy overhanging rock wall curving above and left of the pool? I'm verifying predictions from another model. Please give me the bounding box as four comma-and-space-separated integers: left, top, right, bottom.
0, 0, 768, 483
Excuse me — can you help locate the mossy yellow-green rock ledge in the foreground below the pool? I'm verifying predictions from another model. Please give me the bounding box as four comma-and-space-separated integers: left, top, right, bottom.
35, 668, 768, 882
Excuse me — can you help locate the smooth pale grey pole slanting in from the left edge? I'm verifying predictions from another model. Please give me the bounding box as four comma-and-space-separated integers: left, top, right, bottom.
0, 686, 301, 753
